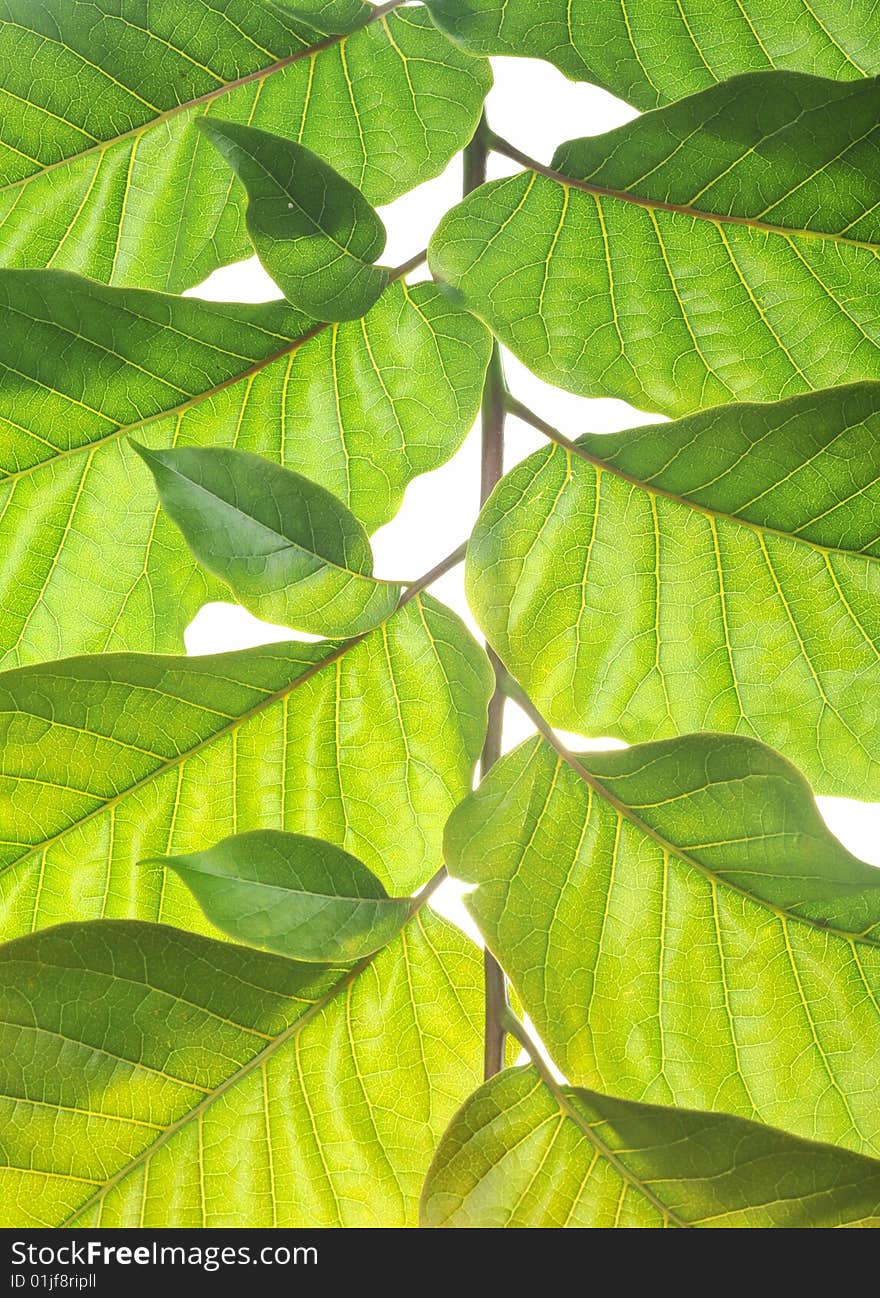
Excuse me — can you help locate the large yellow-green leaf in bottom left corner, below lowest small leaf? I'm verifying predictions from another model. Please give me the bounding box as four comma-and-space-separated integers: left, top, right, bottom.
0, 911, 482, 1229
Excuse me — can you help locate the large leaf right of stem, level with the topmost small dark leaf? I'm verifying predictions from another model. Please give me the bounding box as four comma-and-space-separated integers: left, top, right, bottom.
431, 73, 880, 415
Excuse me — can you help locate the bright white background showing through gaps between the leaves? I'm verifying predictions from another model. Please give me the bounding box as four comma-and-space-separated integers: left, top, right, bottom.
187, 55, 880, 937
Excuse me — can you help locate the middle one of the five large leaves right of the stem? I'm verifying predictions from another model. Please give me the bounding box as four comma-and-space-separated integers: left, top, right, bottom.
467, 384, 880, 798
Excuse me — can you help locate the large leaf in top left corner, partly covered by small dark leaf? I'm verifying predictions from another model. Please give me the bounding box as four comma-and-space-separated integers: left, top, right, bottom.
0, 0, 491, 289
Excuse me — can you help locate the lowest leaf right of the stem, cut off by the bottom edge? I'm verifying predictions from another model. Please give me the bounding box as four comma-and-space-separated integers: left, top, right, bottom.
422, 1068, 880, 1231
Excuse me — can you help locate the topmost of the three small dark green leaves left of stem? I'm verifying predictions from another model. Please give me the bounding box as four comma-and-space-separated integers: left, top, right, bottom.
205, 117, 388, 321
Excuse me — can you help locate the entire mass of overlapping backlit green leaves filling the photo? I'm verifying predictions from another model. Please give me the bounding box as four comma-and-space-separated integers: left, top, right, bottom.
0, 0, 880, 1228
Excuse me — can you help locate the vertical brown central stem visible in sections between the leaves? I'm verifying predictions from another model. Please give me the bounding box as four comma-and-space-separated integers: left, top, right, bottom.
462, 117, 507, 1080
